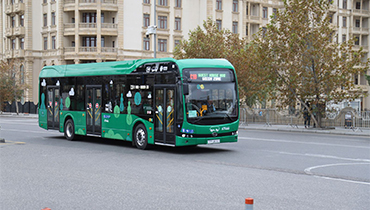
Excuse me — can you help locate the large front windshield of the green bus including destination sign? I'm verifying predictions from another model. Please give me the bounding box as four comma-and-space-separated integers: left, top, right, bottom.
185, 70, 238, 125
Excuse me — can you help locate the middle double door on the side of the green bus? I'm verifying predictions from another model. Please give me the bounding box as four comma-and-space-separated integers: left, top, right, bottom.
86, 86, 102, 135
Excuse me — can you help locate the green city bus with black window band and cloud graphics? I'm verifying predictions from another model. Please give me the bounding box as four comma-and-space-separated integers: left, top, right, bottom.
38, 58, 239, 149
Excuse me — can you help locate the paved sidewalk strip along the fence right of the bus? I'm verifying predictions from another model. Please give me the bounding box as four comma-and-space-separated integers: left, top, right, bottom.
239, 123, 370, 137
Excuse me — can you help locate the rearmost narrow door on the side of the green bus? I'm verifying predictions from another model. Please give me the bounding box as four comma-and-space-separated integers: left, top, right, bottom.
47, 86, 60, 130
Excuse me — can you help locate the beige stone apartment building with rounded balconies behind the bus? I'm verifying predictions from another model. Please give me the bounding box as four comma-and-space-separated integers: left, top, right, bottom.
0, 0, 370, 109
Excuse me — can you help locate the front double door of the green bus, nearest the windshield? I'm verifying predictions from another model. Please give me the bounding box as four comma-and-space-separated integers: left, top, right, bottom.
154, 87, 175, 145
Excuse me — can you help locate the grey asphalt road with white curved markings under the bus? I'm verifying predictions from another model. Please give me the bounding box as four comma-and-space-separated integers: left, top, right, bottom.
0, 117, 370, 210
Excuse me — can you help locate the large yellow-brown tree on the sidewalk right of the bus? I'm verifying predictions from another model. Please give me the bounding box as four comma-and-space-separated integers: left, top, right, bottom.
253, 0, 369, 127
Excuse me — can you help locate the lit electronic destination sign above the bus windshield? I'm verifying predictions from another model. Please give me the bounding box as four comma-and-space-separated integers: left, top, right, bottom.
184, 69, 233, 82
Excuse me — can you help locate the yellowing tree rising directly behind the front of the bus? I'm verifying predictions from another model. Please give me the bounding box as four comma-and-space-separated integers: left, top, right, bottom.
174, 19, 266, 105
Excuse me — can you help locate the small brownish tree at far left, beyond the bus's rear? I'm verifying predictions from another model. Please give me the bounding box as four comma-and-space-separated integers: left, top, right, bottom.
0, 61, 26, 114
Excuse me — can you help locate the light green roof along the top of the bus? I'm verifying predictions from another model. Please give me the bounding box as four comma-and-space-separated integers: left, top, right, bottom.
39, 58, 234, 78
